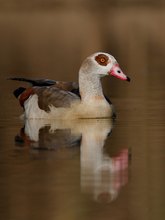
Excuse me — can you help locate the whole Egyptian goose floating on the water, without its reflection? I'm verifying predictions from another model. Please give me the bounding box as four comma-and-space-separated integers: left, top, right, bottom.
11, 52, 130, 119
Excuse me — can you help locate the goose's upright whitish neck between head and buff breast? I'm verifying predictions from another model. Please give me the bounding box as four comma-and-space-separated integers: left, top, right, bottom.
79, 69, 104, 102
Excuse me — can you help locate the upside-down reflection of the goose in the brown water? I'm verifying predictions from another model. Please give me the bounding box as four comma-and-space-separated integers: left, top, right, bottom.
15, 119, 129, 203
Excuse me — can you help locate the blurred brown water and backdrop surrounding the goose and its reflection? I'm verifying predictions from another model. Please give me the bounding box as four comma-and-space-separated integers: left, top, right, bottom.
0, 0, 165, 220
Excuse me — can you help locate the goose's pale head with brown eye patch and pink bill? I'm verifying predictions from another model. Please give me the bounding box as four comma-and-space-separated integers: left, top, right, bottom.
80, 52, 130, 81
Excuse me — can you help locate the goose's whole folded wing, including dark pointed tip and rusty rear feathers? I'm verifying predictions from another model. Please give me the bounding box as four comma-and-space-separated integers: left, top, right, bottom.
10, 78, 80, 111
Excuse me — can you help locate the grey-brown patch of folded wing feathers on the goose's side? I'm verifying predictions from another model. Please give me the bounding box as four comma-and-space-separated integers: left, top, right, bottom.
33, 86, 80, 111
